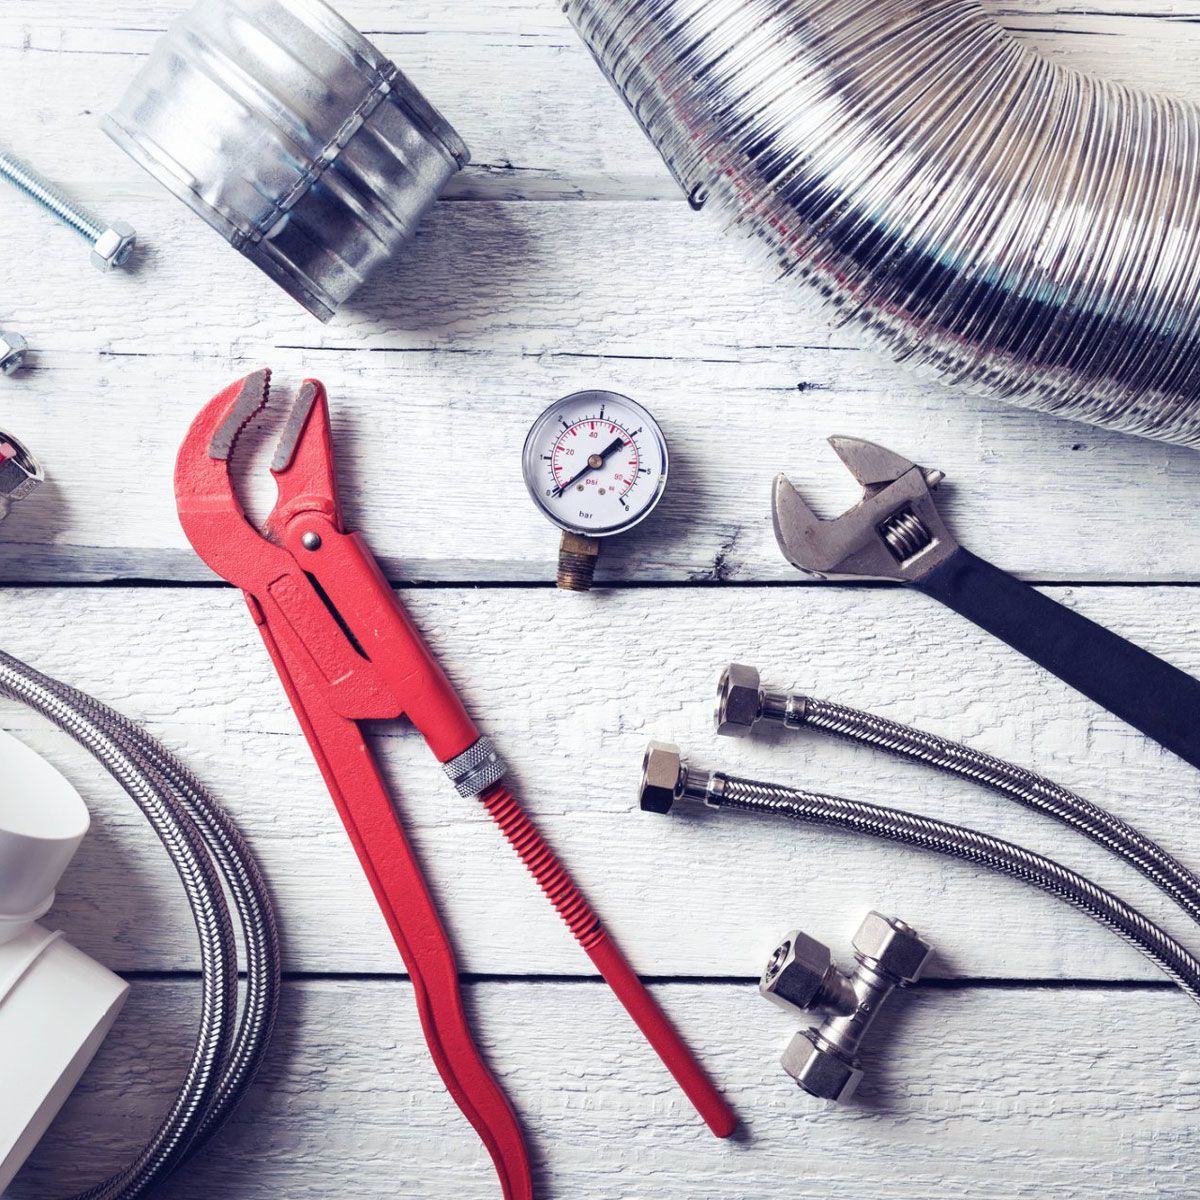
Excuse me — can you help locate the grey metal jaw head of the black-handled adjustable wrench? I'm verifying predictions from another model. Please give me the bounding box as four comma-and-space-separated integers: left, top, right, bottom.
773, 437, 958, 583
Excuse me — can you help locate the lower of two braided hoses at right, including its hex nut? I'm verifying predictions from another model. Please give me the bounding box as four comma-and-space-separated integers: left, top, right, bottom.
642, 743, 1200, 1003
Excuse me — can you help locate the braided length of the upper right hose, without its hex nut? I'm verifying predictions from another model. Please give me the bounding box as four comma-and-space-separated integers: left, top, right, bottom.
787, 696, 1200, 924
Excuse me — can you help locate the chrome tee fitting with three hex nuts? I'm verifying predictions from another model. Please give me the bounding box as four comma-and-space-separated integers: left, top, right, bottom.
758, 912, 932, 1100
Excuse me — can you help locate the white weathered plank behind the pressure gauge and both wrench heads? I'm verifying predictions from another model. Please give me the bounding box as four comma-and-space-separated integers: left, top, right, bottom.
7, 201, 1200, 581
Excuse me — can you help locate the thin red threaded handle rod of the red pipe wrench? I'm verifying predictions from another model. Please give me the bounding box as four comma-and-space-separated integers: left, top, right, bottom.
480, 784, 738, 1138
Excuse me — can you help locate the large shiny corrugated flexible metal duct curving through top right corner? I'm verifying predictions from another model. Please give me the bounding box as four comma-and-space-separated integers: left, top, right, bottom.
565, 0, 1200, 445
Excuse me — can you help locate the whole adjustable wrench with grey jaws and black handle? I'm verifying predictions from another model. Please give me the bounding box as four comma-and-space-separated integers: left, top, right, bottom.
774, 437, 1200, 767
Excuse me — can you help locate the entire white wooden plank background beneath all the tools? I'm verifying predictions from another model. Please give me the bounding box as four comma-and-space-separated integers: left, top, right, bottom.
7, 0, 1200, 1200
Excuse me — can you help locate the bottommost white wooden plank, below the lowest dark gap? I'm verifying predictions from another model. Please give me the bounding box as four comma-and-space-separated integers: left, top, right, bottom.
11, 982, 1198, 1200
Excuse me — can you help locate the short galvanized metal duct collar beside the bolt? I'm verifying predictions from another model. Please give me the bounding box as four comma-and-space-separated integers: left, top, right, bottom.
104, 0, 469, 320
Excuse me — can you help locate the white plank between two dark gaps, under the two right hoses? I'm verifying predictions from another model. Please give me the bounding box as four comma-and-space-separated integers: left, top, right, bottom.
9, 588, 1200, 979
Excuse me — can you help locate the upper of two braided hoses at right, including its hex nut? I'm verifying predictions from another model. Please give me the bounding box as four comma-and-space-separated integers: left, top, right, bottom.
716, 664, 1200, 924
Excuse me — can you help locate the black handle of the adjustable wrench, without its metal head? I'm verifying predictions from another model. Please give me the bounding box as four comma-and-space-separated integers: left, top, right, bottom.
913, 546, 1200, 767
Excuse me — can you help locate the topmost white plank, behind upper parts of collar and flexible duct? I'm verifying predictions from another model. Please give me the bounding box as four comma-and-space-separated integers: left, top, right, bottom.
7, 0, 1200, 204
